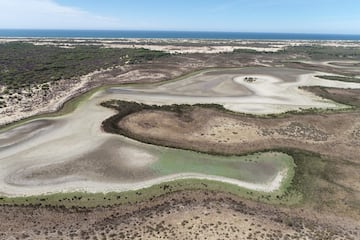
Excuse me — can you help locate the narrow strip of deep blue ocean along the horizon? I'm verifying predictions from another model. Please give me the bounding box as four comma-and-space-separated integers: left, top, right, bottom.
0, 29, 360, 41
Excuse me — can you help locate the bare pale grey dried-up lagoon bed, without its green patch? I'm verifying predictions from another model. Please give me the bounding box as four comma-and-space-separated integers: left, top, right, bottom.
0, 68, 359, 196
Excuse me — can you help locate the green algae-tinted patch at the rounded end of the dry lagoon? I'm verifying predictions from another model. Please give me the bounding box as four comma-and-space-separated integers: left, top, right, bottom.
150, 149, 294, 183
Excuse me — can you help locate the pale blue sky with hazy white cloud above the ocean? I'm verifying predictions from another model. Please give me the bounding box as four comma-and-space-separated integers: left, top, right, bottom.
0, 0, 360, 34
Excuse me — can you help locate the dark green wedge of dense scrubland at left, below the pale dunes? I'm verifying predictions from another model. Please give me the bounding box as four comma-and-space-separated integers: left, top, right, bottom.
0, 42, 169, 91
